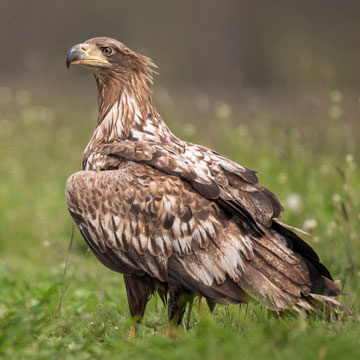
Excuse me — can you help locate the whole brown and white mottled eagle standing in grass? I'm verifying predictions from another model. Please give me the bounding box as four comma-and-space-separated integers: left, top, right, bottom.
66, 37, 341, 331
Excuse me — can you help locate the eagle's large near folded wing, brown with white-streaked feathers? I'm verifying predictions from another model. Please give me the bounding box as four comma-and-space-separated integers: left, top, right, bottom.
66, 161, 324, 310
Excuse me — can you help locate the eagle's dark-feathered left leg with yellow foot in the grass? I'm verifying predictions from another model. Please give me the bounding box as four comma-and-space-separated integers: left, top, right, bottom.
124, 275, 155, 340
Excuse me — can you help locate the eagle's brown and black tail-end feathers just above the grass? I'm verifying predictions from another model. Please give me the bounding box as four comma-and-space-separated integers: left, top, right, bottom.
235, 226, 349, 315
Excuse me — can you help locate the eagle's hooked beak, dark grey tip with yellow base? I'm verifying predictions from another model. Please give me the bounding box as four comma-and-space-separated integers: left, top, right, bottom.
66, 44, 109, 69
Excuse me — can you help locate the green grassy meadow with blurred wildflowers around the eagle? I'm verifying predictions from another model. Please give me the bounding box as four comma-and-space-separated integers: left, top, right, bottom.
0, 89, 360, 360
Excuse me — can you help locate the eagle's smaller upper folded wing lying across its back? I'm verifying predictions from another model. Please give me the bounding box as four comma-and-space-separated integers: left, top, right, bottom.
102, 140, 282, 235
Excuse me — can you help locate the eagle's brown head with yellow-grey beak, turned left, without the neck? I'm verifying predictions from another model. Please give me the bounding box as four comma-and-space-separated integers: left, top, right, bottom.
66, 37, 155, 80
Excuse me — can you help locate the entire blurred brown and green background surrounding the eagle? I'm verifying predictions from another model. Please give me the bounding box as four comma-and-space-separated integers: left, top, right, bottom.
0, 0, 360, 360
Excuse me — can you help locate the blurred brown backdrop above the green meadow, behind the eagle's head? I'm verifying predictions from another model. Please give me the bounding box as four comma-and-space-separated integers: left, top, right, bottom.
0, 0, 360, 136
